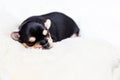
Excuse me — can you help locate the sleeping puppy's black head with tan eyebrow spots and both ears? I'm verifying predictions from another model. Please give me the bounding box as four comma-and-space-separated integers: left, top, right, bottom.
11, 19, 53, 49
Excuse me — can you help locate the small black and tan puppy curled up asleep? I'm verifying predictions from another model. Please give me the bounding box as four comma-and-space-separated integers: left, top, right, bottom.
11, 12, 79, 49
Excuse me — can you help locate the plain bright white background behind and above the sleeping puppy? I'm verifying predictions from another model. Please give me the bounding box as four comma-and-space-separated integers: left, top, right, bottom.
2, 0, 120, 47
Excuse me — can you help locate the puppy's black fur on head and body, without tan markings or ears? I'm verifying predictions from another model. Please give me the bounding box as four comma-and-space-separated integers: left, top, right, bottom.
11, 12, 79, 46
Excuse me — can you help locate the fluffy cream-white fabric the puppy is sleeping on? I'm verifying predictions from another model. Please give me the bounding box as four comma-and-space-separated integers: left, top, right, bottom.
0, 11, 115, 80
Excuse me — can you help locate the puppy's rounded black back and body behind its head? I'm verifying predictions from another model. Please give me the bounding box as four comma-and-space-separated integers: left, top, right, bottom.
42, 12, 79, 42
